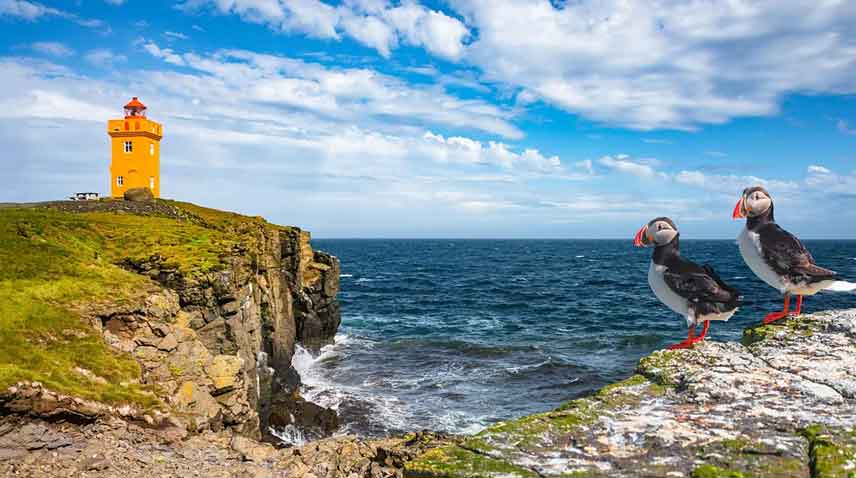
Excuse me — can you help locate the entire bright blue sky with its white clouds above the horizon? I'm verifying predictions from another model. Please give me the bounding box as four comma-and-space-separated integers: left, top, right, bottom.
0, 0, 856, 238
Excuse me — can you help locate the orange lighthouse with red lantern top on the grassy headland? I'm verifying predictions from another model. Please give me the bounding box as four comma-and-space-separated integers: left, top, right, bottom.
107, 96, 163, 198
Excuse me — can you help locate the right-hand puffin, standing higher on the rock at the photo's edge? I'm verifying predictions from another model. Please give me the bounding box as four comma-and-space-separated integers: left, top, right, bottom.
731, 186, 856, 324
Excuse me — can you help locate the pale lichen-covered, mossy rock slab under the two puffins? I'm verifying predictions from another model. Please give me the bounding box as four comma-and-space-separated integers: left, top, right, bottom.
407, 309, 856, 478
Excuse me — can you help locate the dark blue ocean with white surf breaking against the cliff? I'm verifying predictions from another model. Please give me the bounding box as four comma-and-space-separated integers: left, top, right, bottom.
295, 240, 856, 436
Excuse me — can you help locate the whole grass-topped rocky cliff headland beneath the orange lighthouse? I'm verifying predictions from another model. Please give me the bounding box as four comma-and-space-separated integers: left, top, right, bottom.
0, 201, 339, 438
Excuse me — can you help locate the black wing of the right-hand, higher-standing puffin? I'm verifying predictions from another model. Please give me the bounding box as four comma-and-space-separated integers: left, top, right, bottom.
758, 223, 835, 282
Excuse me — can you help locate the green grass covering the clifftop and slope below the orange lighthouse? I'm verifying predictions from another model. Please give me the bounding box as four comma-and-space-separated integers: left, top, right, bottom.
0, 203, 272, 407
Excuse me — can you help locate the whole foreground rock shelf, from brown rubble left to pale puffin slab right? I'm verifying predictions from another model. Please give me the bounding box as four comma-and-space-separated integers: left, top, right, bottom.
0, 309, 856, 478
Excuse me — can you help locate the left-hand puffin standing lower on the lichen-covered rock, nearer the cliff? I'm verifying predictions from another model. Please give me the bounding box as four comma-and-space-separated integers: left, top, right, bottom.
633, 217, 741, 349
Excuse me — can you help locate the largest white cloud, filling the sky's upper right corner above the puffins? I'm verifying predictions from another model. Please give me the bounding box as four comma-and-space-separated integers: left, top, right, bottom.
451, 0, 856, 130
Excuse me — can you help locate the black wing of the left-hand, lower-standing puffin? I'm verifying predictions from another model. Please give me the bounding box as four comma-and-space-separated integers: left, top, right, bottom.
663, 258, 740, 313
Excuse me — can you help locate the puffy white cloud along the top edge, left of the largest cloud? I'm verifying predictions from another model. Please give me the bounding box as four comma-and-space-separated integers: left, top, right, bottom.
179, 0, 469, 60
